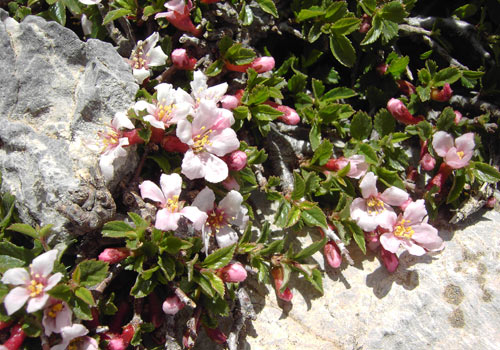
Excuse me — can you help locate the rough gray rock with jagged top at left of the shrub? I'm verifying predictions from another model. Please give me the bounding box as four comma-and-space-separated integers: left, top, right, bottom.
0, 9, 138, 239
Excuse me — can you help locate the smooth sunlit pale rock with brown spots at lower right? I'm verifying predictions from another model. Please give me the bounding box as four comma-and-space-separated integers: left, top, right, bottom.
199, 211, 500, 350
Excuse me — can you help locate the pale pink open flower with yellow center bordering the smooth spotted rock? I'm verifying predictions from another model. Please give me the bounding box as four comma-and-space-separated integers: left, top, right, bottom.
380, 199, 444, 256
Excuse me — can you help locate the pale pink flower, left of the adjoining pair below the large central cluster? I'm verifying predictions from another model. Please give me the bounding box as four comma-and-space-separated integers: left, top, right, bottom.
139, 173, 207, 231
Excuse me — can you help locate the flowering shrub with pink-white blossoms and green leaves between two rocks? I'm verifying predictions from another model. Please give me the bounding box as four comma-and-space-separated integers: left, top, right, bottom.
0, 0, 500, 350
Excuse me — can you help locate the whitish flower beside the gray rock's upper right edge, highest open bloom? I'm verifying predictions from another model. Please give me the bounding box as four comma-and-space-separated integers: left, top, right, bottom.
128, 32, 168, 84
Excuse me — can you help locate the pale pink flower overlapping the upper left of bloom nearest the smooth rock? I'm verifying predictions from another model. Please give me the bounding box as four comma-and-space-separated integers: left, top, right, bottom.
350, 172, 409, 231
